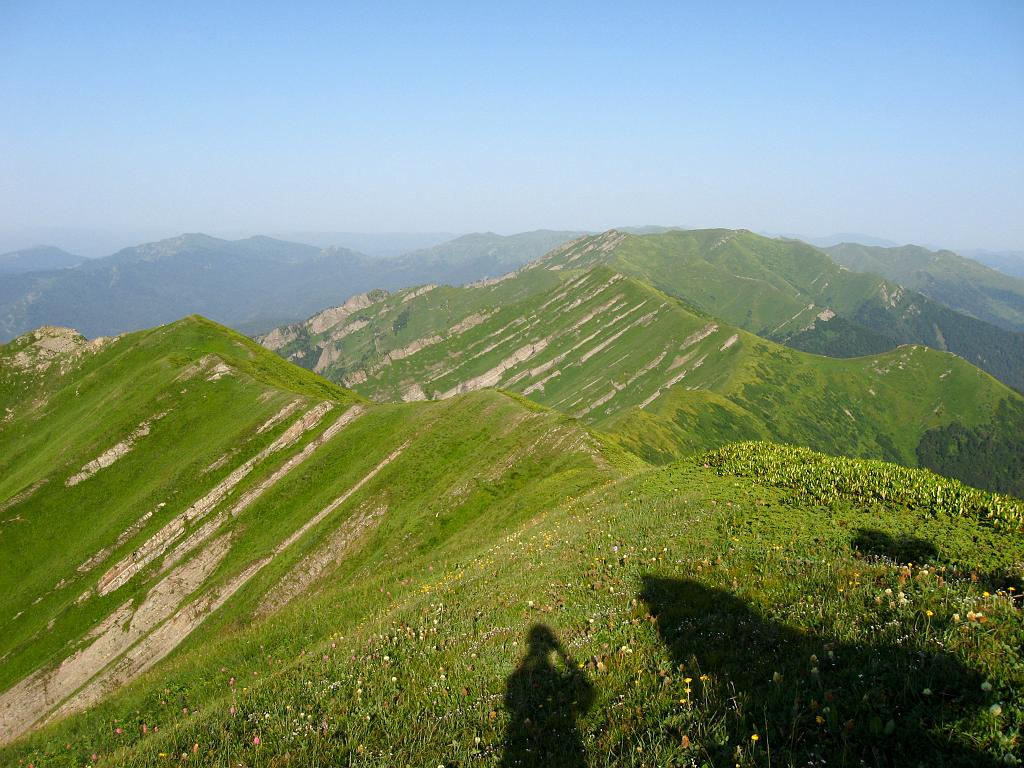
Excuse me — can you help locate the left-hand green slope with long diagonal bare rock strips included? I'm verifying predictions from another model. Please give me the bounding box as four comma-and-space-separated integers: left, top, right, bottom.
0, 317, 616, 740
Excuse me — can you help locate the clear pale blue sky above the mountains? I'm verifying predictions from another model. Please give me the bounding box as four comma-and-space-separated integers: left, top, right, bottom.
0, 0, 1024, 249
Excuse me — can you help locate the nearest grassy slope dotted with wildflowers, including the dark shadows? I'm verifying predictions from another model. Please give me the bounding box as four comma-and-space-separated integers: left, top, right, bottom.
2, 455, 1024, 766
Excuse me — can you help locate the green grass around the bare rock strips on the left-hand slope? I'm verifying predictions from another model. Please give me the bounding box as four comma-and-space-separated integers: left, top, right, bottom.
0, 318, 630, 757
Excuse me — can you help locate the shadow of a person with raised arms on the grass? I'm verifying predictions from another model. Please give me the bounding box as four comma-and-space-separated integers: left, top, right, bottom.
502, 624, 594, 768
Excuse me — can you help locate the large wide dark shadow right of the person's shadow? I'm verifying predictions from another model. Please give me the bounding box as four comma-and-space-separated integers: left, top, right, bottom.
641, 577, 997, 768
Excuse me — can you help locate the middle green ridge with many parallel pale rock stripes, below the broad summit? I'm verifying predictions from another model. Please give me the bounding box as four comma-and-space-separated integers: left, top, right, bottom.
262, 262, 1024, 494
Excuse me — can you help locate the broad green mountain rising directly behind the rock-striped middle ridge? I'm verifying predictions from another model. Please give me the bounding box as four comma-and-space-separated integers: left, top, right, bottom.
537, 229, 1024, 391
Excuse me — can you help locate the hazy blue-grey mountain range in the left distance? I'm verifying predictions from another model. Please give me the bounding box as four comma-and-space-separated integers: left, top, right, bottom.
0, 231, 572, 340
